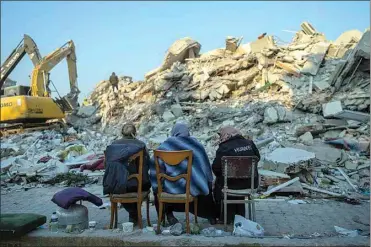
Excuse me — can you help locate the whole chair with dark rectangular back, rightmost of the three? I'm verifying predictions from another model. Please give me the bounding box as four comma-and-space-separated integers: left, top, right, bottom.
221, 156, 258, 230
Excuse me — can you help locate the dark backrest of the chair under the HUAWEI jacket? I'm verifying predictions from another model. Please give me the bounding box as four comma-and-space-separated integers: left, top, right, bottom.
222, 156, 258, 189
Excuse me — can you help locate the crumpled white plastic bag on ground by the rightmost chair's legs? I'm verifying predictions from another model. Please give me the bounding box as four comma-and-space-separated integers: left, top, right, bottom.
233, 215, 264, 237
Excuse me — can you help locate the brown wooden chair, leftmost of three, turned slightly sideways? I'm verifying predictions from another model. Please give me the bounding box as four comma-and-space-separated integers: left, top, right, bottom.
110, 150, 151, 229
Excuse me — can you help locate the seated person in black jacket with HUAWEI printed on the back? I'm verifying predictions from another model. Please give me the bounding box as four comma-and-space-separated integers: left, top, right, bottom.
212, 126, 260, 224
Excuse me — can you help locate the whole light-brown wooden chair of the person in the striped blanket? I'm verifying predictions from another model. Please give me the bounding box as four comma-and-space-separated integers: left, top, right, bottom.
154, 150, 197, 234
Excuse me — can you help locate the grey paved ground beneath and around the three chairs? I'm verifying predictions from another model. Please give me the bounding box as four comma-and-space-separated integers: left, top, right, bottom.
1, 185, 370, 246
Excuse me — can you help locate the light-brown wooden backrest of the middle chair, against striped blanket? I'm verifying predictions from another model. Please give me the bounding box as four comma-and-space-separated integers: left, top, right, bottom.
154, 150, 193, 200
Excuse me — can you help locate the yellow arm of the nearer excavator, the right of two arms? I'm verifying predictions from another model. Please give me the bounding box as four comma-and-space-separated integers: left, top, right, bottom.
31, 40, 80, 108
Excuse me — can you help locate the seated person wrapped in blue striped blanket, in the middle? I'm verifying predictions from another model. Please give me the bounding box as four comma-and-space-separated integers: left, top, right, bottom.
150, 123, 217, 225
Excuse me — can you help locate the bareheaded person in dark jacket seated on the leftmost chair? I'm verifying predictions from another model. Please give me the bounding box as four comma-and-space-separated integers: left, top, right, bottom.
103, 123, 151, 224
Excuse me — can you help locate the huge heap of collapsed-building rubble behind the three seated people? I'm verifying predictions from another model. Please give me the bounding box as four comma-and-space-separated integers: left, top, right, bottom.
1, 23, 370, 199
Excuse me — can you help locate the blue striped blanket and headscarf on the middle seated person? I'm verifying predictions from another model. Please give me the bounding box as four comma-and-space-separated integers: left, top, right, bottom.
150, 135, 213, 196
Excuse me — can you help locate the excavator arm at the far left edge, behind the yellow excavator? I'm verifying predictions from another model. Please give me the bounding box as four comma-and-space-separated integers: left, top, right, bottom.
0, 34, 44, 88
